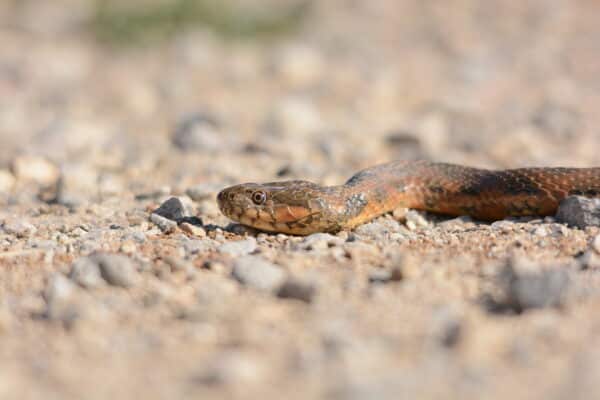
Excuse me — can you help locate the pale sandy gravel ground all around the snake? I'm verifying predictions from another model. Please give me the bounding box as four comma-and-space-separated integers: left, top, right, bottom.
0, 0, 600, 399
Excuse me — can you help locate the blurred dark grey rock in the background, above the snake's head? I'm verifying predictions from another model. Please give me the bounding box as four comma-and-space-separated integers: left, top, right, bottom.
172, 113, 226, 151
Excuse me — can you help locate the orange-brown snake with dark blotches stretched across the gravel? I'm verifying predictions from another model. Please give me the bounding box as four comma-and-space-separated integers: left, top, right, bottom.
217, 160, 600, 235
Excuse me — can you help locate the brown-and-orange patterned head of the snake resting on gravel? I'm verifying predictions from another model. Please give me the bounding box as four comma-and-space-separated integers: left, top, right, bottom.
217, 181, 332, 235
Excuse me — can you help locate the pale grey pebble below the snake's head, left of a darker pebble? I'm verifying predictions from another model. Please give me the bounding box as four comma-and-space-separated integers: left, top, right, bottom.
231, 256, 286, 291
